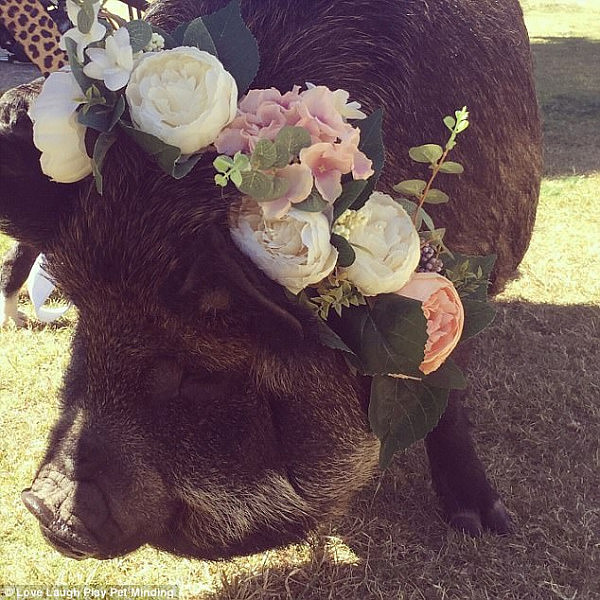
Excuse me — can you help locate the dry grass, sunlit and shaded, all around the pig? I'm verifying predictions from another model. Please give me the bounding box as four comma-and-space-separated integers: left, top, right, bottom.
0, 0, 600, 600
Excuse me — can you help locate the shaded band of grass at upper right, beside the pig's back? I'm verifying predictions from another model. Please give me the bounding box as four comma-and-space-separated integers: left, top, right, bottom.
531, 38, 600, 176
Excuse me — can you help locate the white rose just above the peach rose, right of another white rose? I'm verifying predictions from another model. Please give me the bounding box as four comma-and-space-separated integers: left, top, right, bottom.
345, 192, 421, 296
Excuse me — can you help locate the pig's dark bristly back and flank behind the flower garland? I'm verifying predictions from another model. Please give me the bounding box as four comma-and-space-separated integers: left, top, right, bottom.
148, 0, 541, 293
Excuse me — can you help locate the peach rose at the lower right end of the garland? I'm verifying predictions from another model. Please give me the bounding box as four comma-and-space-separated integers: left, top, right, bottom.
396, 273, 465, 375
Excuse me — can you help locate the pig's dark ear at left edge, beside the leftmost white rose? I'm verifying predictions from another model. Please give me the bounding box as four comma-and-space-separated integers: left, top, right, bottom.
0, 80, 74, 249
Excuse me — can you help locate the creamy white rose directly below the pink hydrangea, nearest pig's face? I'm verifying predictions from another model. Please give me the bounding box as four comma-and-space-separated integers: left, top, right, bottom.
231, 199, 338, 294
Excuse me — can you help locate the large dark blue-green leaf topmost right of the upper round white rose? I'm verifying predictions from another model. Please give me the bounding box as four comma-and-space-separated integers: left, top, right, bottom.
202, 0, 260, 96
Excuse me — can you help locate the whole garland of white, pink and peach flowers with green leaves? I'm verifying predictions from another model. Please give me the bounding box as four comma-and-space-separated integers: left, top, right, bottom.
30, 0, 494, 466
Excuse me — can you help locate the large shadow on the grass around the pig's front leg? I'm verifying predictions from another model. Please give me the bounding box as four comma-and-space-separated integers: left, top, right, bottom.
203, 302, 600, 600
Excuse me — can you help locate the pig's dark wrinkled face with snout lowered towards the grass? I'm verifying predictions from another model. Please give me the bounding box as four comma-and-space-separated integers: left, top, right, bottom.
23, 151, 376, 558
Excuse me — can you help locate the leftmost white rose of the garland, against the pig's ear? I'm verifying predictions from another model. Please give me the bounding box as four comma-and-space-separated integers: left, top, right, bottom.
29, 71, 92, 183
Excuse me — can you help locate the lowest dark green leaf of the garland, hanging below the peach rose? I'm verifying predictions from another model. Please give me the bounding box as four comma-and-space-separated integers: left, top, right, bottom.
369, 376, 449, 468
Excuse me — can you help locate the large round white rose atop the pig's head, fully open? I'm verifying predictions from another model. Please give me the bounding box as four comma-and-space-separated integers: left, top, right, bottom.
125, 47, 237, 154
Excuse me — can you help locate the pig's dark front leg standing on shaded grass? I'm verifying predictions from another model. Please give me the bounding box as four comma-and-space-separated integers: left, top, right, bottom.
425, 390, 512, 536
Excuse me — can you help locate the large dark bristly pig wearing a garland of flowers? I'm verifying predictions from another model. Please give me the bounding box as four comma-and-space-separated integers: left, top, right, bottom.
0, 0, 541, 558
